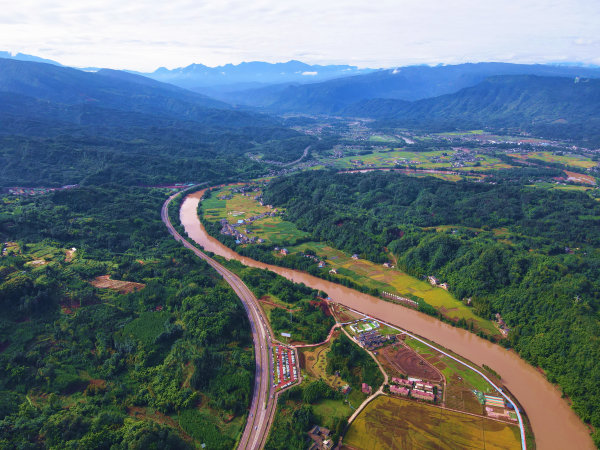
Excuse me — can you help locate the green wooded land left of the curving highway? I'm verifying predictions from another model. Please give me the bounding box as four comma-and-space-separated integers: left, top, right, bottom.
0, 186, 254, 449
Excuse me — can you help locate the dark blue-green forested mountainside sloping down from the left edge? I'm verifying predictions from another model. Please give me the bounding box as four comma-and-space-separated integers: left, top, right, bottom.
0, 59, 308, 187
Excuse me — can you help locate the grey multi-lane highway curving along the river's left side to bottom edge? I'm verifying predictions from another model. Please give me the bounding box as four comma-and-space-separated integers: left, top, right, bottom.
161, 194, 277, 450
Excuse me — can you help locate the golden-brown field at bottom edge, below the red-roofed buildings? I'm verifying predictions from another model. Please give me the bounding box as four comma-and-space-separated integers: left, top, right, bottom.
343, 396, 520, 450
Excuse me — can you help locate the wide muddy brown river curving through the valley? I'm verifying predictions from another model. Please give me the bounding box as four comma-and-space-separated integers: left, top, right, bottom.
180, 192, 595, 450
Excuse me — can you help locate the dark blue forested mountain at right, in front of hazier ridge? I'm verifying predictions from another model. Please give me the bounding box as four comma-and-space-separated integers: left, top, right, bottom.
344, 75, 600, 143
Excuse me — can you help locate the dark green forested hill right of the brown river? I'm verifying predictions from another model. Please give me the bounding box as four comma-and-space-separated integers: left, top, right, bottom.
264, 171, 600, 444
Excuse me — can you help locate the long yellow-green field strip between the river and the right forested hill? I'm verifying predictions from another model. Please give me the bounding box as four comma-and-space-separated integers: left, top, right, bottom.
289, 242, 498, 335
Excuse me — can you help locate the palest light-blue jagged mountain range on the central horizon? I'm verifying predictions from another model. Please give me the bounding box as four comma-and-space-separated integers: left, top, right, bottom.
140, 60, 374, 92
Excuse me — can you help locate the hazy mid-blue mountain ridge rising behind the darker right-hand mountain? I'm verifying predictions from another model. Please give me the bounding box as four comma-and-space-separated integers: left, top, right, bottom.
218, 63, 600, 114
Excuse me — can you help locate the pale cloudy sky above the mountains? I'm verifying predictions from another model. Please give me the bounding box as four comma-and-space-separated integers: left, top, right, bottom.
0, 0, 600, 71
